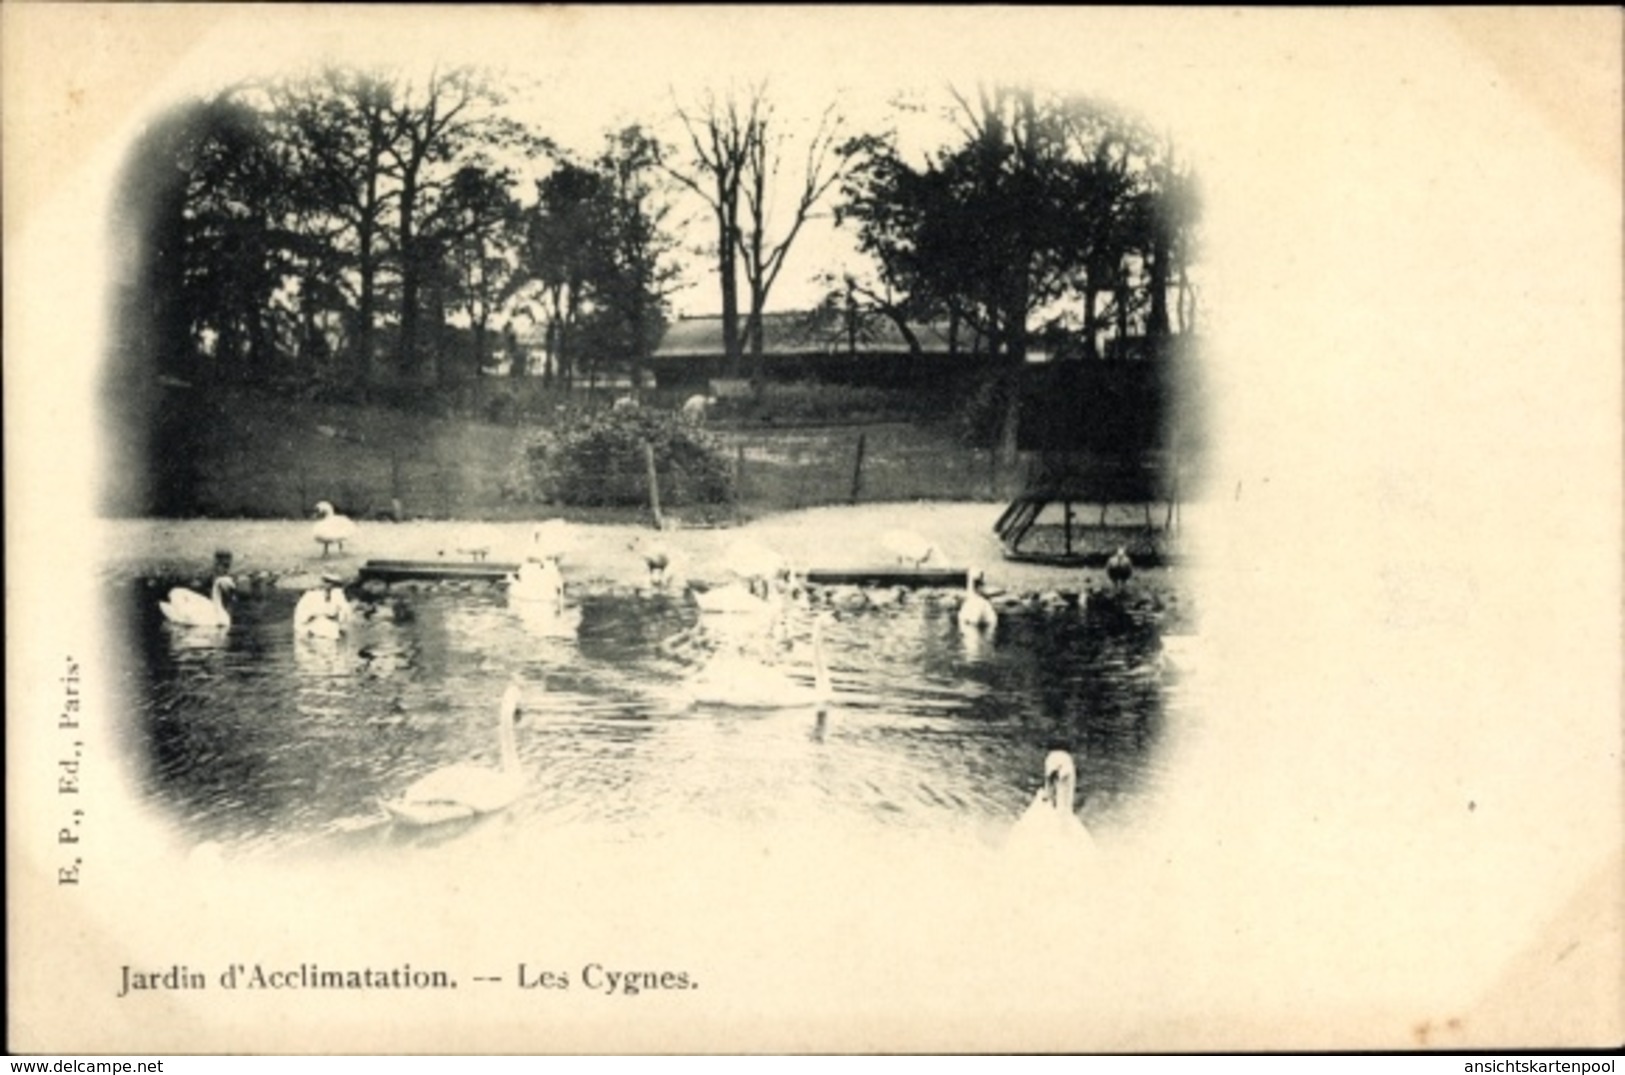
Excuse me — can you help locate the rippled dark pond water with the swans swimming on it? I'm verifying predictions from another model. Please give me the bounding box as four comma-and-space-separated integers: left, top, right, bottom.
122, 583, 1181, 854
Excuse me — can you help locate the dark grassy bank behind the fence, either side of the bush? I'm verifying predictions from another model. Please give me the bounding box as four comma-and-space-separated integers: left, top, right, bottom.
136, 390, 1009, 523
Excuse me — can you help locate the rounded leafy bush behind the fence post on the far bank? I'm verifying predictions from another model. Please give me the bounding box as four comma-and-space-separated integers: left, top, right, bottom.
522, 408, 735, 507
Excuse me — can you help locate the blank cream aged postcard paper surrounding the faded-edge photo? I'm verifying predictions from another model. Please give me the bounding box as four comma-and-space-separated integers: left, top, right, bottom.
0, 3, 1625, 1052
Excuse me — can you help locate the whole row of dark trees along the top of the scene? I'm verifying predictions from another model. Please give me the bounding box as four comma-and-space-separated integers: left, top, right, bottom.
114, 68, 1199, 409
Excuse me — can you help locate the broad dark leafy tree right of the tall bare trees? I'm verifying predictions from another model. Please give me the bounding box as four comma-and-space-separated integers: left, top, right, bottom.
837, 86, 1196, 460
